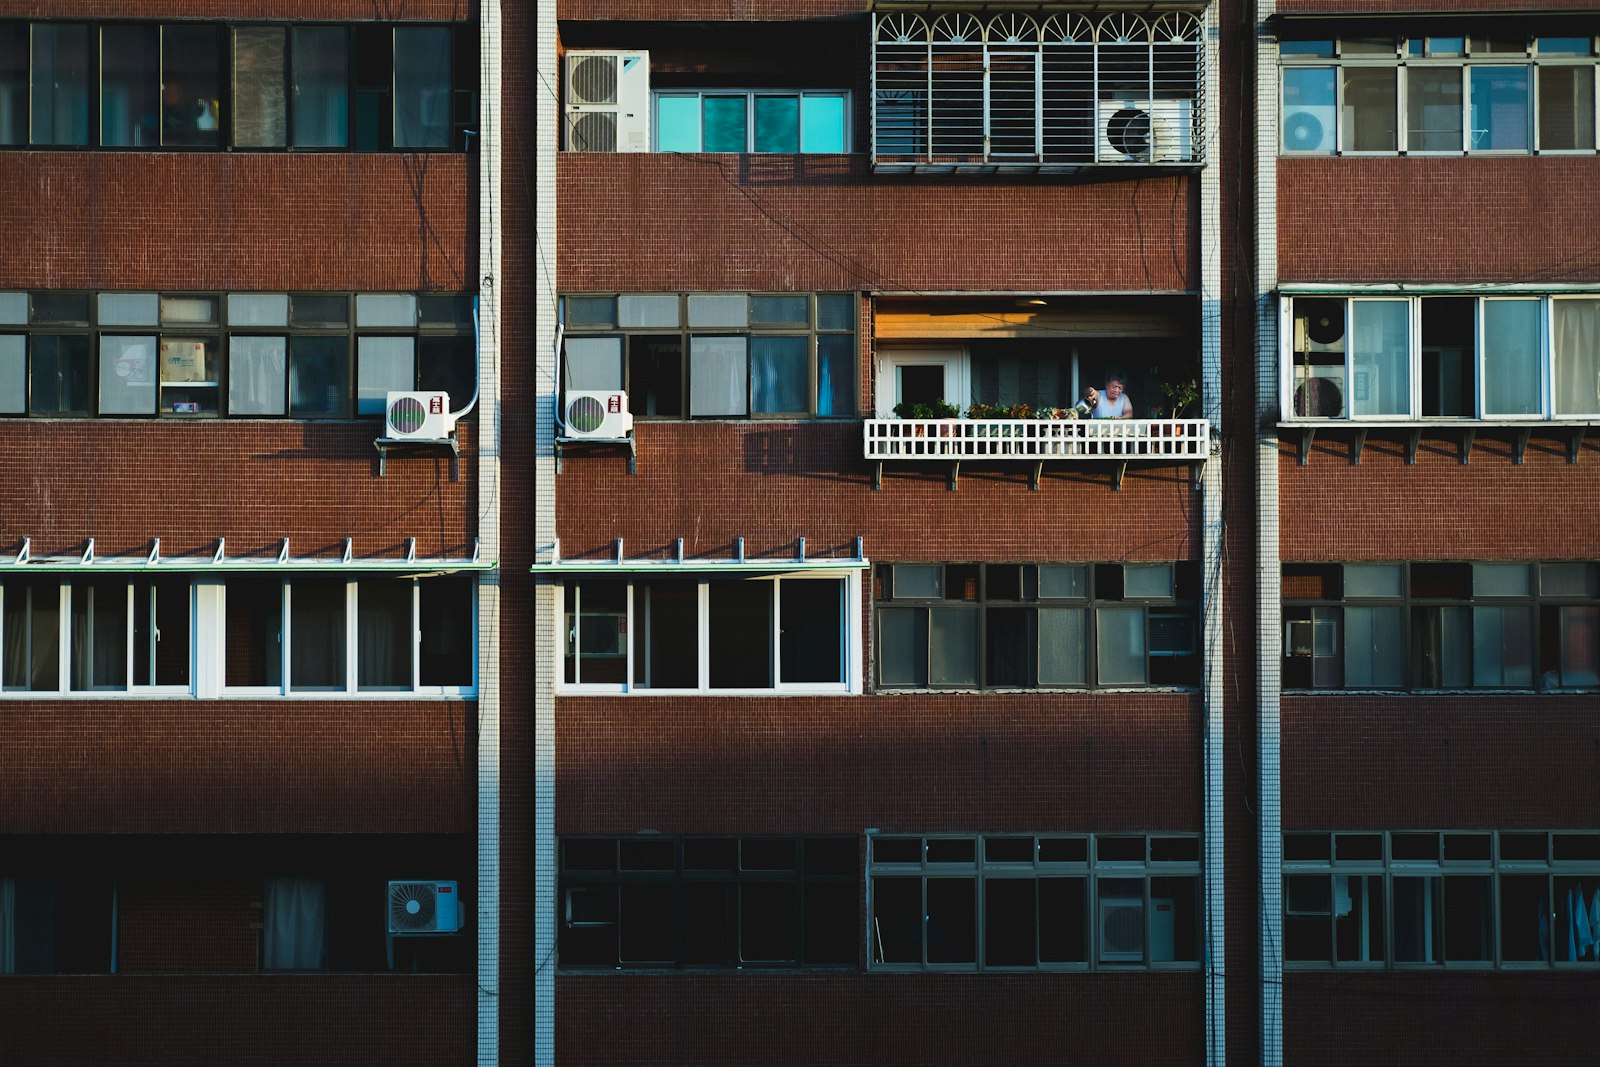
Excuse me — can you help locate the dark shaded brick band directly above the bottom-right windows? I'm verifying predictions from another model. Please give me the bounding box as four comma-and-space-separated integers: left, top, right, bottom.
1282, 694, 1600, 830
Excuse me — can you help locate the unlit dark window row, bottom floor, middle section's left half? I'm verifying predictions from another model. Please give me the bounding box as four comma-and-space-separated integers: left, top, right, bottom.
558, 837, 859, 969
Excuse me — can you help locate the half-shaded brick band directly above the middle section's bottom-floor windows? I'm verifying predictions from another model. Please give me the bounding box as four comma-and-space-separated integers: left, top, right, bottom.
555, 693, 1200, 833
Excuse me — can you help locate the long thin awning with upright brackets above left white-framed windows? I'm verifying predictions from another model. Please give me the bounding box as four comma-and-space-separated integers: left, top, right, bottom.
0, 537, 498, 577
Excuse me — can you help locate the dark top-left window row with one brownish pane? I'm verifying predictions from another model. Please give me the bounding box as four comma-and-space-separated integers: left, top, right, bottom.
0, 21, 478, 152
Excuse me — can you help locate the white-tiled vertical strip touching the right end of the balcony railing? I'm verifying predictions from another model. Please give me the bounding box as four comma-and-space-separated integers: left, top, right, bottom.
1200, 3, 1227, 1067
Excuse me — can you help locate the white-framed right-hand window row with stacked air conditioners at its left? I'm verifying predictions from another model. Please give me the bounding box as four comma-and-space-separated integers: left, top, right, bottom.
1283, 293, 1600, 421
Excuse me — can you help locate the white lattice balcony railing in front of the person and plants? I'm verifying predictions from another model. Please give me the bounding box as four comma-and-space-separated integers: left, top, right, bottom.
864, 419, 1211, 461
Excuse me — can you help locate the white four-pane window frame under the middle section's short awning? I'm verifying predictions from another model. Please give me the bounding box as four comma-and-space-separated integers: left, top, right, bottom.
550, 566, 862, 696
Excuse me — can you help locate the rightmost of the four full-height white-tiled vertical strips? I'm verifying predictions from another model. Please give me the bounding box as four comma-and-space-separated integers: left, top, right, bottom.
1254, 0, 1283, 1067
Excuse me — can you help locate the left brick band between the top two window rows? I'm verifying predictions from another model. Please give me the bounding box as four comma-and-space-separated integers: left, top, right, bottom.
0, 153, 477, 290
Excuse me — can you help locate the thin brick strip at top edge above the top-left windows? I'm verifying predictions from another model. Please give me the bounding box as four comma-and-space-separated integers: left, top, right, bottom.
0, 0, 477, 22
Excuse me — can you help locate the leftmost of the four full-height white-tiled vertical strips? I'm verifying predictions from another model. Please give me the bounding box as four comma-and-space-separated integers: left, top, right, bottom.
475, 0, 501, 1067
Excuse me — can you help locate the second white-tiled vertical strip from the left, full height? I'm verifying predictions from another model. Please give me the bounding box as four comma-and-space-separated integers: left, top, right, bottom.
530, 0, 562, 1067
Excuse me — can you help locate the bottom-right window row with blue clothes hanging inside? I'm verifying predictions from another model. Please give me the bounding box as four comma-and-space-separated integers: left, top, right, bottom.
1283, 830, 1600, 968
